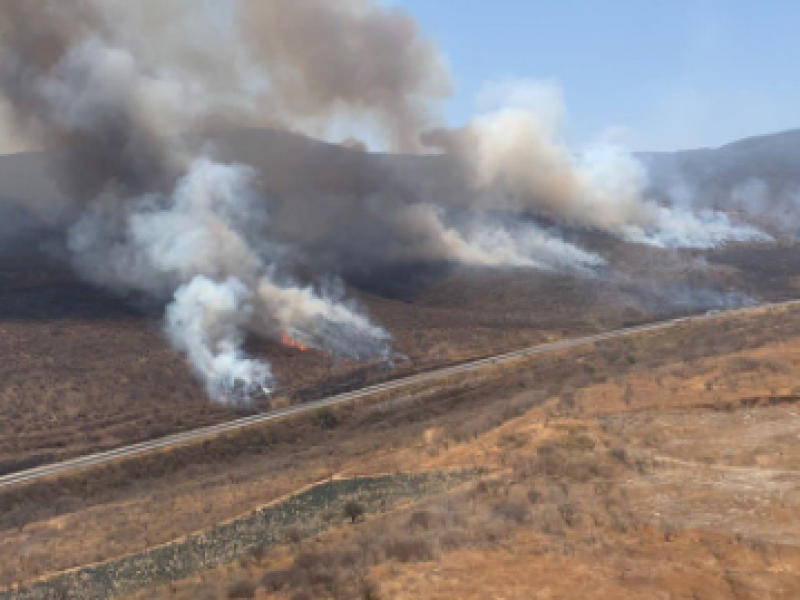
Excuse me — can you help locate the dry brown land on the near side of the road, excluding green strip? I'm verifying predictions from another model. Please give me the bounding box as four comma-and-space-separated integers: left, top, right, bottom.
0, 308, 800, 598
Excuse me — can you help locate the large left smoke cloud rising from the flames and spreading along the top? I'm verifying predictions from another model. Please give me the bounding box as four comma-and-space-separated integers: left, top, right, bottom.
0, 0, 438, 402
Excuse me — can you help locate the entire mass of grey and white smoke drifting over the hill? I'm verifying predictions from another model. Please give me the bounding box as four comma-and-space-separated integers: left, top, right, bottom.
0, 0, 763, 402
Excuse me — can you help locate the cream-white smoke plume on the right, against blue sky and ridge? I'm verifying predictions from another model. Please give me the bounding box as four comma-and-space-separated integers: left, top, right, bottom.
440, 81, 767, 247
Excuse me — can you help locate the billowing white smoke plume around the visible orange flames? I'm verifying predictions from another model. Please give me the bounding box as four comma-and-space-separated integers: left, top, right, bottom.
69, 159, 389, 402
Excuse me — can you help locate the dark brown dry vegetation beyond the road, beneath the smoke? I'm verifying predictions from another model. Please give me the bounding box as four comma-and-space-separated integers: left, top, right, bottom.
0, 220, 800, 472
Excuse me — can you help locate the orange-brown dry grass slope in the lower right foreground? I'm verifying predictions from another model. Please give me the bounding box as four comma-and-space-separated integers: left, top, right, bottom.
119, 304, 800, 600
